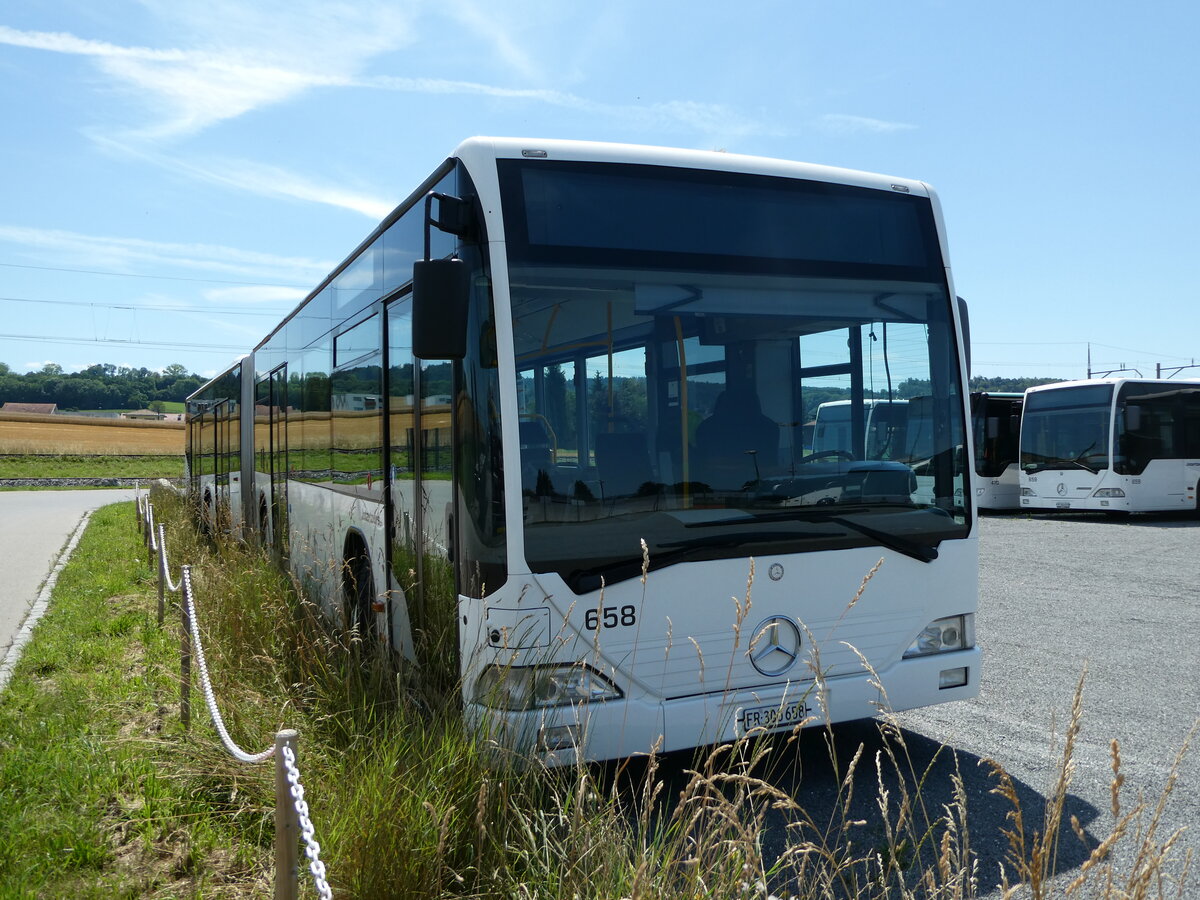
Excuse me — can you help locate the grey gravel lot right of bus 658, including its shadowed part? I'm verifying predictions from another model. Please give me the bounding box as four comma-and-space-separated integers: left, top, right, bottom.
635, 512, 1200, 896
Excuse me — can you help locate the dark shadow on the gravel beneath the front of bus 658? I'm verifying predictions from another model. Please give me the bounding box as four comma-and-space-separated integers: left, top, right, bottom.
609, 719, 1100, 893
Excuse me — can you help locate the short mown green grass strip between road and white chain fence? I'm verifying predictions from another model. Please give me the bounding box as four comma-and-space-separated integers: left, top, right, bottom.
0, 504, 262, 898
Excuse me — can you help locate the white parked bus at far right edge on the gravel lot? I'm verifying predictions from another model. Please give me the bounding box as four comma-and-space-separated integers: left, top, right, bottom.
1020, 378, 1200, 512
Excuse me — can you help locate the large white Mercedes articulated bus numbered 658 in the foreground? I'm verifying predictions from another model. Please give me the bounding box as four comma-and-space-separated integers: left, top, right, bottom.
188, 138, 980, 763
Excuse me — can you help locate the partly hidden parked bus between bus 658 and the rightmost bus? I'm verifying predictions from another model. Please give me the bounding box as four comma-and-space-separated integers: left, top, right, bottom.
971, 391, 1025, 509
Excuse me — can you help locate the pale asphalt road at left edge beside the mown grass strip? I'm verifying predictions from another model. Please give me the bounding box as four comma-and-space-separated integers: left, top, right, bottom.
0, 490, 134, 681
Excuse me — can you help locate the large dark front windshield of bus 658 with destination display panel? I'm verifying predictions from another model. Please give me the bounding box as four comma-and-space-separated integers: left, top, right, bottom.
499, 160, 968, 593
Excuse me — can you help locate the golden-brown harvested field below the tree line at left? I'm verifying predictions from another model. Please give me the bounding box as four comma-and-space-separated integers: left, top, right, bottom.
0, 413, 186, 456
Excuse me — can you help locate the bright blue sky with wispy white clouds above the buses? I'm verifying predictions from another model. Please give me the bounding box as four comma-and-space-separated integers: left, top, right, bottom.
0, 0, 1200, 378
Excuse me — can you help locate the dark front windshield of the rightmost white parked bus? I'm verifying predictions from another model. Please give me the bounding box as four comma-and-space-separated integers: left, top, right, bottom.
1021, 384, 1112, 473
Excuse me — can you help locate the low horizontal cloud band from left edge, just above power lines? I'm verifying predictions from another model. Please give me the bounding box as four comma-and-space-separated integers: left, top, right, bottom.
0, 226, 332, 284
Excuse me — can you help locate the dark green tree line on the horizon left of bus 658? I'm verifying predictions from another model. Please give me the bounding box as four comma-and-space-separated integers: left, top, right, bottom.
0, 362, 205, 410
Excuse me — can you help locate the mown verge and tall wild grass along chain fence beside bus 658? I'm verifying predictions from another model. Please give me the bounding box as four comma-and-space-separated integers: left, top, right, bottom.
0, 492, 1194, 900
